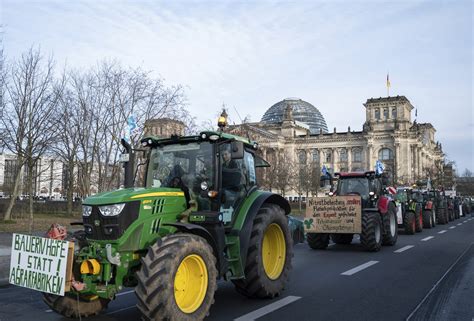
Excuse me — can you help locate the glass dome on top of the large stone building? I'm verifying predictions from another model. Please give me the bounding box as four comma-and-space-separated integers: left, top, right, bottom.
262, 98, 328, 134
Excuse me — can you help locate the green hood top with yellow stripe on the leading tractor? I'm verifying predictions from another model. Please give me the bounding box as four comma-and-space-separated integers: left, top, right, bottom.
83, 188, 184, 205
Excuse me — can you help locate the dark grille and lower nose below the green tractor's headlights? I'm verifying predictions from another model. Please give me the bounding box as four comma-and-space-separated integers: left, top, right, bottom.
83, 201, 140, 240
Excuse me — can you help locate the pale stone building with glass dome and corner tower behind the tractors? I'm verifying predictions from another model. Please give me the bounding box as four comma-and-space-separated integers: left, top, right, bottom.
229, 96, 444, 193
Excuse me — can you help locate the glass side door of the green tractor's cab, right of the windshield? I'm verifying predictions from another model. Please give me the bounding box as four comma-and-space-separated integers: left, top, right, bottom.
218, 143, 256, 225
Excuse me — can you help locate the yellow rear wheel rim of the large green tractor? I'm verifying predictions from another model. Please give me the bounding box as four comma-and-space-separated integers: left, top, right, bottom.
262, 223, 286, 280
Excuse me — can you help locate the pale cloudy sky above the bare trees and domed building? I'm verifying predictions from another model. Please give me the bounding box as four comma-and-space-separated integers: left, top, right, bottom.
0, 0, 474, 173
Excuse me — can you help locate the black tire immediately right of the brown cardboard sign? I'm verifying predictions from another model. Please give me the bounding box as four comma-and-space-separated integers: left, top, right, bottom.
360, 212, 382, 252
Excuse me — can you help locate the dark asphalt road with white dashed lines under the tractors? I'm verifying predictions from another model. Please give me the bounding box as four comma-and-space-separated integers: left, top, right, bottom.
0, 212, 474, 321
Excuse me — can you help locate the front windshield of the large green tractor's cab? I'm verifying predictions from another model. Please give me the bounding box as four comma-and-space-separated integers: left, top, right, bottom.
146, 142, 214, 192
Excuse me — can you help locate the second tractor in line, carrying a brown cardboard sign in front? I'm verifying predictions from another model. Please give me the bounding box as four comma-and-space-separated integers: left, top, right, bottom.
304, 171, 398, 251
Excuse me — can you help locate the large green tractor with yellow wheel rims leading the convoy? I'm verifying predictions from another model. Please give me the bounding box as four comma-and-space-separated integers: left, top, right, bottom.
44, 131, 293, 320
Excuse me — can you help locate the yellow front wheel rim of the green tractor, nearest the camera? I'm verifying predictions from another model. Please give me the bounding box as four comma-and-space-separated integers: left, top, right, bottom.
174, 254, 208, 313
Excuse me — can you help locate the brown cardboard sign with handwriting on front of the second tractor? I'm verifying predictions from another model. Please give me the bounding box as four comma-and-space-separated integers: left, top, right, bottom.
304, 195, 362, 233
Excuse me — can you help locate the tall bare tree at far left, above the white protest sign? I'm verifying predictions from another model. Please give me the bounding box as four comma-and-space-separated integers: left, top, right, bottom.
1, 48, 58, 231
